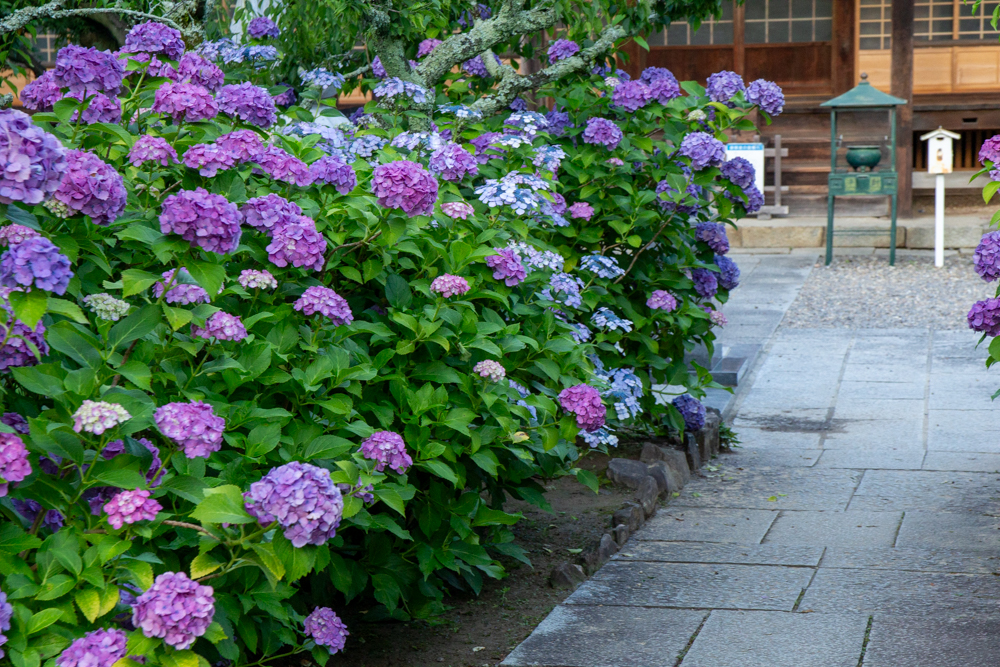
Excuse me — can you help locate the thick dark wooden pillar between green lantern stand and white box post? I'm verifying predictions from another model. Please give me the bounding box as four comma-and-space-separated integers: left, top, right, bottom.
891, 0, 914, 218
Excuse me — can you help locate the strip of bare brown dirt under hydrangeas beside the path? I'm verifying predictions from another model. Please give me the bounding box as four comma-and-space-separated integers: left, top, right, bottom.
336, 446, 639, 667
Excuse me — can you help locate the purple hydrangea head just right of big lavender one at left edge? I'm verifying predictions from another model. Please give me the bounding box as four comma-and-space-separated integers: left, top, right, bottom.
54, 150, 128, 225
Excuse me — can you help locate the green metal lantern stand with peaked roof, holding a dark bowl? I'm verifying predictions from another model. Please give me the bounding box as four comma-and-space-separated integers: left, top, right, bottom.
820, 74, 906, 266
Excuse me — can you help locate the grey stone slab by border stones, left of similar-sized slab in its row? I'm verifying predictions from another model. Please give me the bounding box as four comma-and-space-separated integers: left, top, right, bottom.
636, 507, 778, 544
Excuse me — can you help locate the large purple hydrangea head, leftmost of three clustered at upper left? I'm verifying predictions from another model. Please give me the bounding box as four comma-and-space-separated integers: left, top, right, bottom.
160, 188, 242, 255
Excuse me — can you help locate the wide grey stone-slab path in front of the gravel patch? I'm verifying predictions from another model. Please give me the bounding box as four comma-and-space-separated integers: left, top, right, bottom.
503, 258, 1000, 667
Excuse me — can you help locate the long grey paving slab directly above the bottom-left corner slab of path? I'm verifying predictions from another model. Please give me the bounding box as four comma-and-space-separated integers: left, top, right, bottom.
566, 560, 813, 611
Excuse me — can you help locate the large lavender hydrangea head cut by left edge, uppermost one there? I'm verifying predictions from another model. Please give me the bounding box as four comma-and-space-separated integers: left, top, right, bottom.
0, 109, 68, 204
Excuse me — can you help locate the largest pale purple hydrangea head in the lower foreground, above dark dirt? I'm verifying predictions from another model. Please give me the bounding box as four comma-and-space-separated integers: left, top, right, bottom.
243, 461, 344, 548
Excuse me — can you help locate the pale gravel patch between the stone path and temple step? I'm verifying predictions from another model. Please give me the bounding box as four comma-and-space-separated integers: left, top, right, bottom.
782, 254, 995, 329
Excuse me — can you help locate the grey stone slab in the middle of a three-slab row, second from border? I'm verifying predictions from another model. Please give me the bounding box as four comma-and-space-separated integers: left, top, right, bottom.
764, 512, 903, 547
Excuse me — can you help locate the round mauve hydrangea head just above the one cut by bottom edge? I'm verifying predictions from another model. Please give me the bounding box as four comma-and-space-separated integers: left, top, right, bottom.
132, 572, 215, 651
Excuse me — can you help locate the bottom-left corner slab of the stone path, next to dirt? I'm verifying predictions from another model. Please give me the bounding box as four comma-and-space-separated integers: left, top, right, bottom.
500, 605, 708, 667
